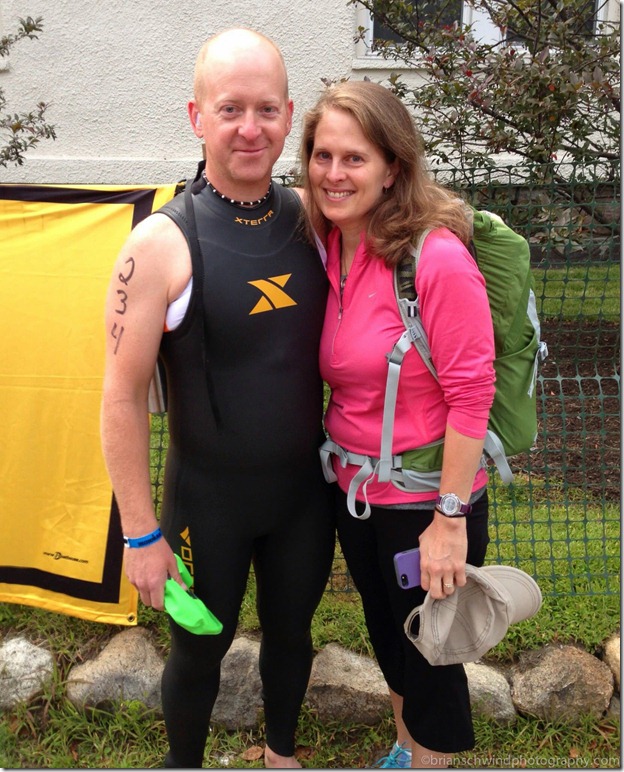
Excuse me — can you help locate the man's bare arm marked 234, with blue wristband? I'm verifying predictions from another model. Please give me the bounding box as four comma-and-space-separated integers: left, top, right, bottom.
101, 215, 191, 609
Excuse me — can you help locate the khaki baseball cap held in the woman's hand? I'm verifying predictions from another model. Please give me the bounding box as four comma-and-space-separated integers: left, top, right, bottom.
404, 565, 542, 665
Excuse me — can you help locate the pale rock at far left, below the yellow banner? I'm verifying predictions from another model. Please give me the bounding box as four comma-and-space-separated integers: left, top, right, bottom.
0, 636, 54, 710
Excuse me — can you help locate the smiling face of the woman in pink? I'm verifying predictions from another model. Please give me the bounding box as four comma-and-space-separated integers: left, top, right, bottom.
308, 109, 398, 233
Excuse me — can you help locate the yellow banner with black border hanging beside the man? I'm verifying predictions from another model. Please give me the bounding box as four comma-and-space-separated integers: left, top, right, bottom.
0, 185, 176, 625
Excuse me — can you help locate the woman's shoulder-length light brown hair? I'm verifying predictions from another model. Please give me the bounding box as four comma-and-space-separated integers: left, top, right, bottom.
301, 81, 471, 266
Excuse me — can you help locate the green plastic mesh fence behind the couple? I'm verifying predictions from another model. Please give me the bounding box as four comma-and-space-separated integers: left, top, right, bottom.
152, 162, 620, 595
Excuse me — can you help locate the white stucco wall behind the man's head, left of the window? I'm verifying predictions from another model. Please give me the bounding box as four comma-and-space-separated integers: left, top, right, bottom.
0, 0, 354, 184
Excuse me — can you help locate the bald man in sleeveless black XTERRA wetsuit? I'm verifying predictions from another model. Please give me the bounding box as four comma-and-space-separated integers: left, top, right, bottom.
102, 29, 334, 768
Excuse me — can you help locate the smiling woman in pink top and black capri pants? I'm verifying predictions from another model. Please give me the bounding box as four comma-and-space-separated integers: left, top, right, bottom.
302, 81, 494, 768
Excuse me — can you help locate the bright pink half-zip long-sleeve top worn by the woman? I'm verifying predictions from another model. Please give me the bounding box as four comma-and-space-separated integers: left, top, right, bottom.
320, 223, 495, 505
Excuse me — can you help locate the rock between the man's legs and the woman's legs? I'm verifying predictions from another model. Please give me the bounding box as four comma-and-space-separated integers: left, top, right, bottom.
306, 643, 391, 724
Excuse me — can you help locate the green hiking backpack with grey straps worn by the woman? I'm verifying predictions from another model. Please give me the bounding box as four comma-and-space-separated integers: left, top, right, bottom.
320, 209, 548, 519
